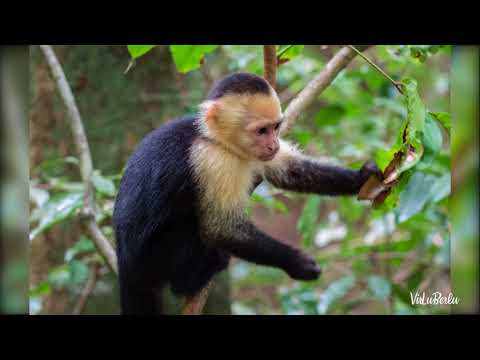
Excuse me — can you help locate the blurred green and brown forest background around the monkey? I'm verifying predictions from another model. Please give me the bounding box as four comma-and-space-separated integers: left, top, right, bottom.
29, 45, 451, 314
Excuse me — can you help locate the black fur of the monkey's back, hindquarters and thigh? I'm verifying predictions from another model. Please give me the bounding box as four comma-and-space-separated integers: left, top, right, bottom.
113, 117, 230, 314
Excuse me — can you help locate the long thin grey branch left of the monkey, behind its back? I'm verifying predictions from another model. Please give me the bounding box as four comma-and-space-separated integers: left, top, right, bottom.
40, 45, 118, 273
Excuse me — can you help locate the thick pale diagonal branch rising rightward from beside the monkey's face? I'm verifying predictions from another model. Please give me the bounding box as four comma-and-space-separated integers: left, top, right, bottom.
281, 45, 368, 134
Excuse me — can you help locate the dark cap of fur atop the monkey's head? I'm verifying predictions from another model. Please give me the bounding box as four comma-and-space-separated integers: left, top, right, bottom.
208, 73, 270, 100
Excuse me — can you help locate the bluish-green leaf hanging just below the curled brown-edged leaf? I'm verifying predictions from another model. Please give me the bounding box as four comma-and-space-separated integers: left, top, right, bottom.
396, 171, 435, 223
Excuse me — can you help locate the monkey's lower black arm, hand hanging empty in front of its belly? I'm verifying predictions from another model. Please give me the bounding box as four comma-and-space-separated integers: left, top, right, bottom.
204, 219, 320, 280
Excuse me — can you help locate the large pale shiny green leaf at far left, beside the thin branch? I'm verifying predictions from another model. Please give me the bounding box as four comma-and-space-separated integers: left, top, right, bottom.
30, 192, 83, 240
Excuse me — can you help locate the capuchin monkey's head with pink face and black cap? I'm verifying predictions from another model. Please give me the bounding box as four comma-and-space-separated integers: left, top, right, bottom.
200, 73, 282, 161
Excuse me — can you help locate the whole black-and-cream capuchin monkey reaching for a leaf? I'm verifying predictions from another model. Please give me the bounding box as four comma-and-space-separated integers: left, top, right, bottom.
113, 73, 379, 314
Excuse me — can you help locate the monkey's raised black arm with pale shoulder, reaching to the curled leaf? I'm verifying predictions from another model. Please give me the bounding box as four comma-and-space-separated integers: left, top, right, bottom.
265, 143, 381, 195
